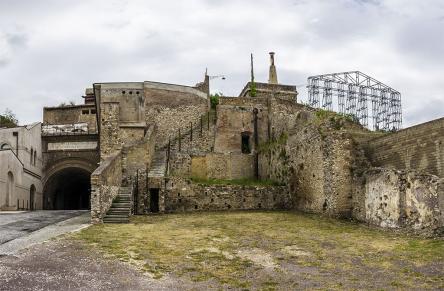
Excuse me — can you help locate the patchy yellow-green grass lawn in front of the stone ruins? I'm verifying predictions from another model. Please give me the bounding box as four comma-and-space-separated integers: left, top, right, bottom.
71, 211, 444, 290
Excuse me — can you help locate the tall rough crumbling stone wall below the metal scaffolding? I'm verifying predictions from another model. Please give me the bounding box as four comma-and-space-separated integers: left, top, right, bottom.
259, 104, 355, 217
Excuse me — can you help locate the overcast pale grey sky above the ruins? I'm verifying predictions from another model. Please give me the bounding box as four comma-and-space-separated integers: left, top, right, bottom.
0, 0, 444, 127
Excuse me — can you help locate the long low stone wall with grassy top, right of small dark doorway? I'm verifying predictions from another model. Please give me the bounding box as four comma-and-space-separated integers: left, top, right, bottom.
164, 177, 291, 212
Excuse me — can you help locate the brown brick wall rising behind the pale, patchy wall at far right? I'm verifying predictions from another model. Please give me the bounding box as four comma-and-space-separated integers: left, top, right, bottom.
366, 118, 444, 177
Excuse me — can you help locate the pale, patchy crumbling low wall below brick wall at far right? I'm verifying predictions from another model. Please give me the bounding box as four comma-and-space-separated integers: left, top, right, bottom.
365, 168, 444, 230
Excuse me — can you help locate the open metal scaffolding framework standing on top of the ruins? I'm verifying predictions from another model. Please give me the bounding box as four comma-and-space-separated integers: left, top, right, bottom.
307, 71, 402, 130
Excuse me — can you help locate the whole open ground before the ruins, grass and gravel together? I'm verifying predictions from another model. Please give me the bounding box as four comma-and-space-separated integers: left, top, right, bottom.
0, 212, 444, 290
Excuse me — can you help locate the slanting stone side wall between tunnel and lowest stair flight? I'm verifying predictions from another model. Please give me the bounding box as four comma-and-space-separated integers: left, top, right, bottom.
91, 152, 122, 223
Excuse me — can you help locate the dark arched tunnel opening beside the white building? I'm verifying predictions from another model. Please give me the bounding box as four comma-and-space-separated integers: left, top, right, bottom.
43, 167, 91, 210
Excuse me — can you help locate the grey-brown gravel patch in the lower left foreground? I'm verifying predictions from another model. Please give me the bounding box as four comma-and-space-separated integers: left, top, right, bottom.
0, 239, 173, 290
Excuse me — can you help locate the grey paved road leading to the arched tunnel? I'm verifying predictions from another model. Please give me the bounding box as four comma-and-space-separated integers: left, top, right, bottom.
0, 210, 89, 246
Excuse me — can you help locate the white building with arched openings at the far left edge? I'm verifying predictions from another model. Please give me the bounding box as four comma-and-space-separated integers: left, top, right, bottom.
0, 122, 43, 210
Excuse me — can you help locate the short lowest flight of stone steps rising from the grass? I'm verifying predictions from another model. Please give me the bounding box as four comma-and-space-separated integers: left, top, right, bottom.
103, 187, 131, 223
